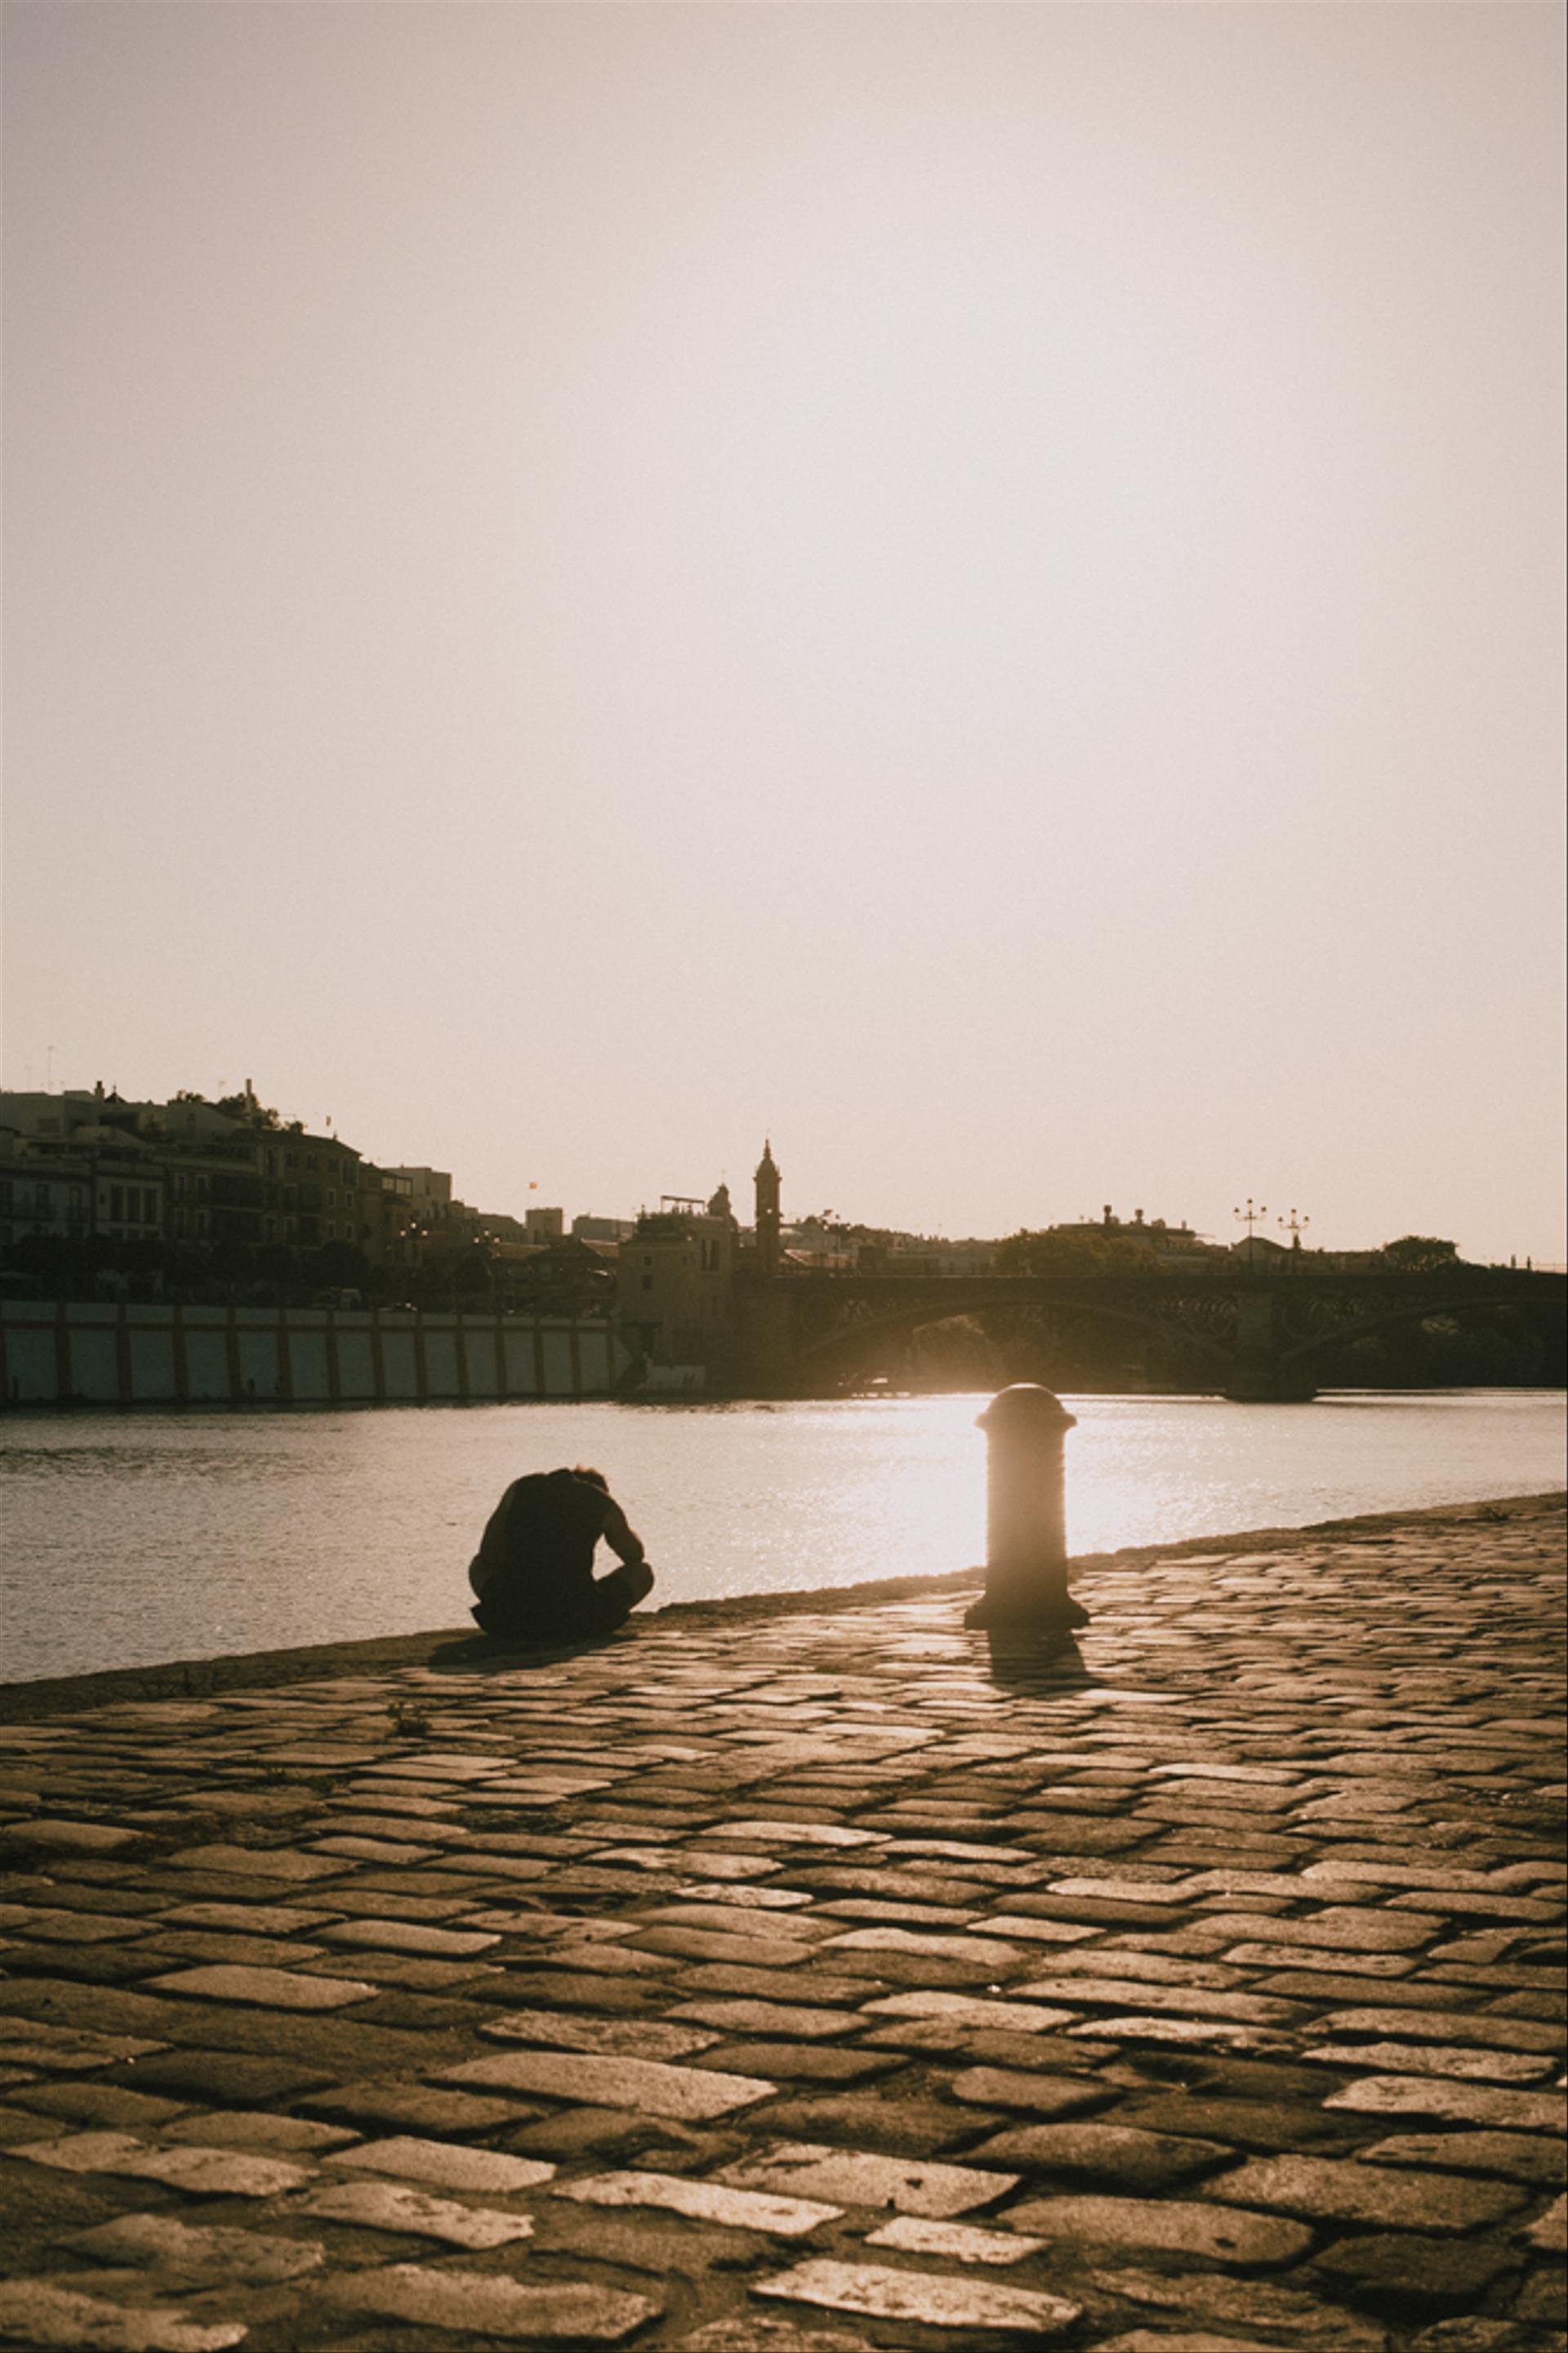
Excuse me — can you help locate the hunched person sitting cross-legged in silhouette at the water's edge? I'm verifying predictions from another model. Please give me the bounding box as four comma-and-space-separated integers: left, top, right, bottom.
469, 1464, 653, 1642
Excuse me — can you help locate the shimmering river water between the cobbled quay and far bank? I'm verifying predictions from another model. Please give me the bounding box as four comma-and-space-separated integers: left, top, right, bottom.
0, 1388, 1568, 1680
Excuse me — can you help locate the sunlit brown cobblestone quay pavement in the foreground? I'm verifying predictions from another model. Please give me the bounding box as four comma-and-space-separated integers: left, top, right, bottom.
0, 1499, 1563, 2353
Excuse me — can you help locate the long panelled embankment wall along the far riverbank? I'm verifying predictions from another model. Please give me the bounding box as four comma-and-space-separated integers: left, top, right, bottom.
0, 1299, 629, 1405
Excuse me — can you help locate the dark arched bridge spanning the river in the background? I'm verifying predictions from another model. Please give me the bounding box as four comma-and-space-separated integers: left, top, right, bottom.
733, 1256, 1568, 1402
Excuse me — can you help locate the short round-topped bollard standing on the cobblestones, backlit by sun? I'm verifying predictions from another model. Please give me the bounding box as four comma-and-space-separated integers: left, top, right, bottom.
963, 1381, 1088, 1631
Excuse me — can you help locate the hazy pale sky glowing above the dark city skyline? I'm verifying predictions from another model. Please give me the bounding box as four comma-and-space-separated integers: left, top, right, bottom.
5, 0, 1568, 1259
